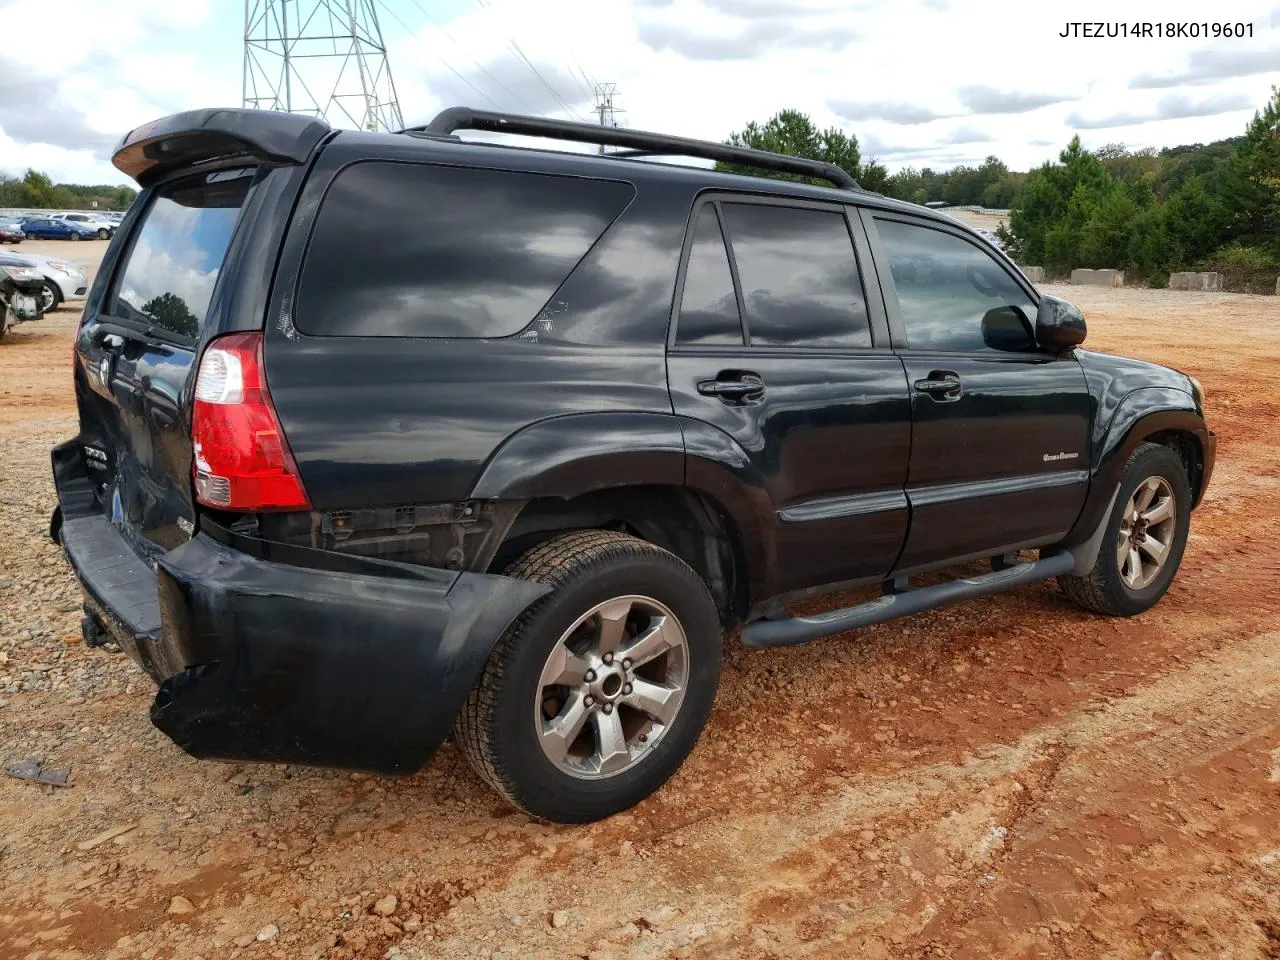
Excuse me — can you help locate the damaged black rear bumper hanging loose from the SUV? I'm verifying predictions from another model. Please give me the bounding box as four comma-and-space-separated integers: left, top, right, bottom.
54, 444, 547, 773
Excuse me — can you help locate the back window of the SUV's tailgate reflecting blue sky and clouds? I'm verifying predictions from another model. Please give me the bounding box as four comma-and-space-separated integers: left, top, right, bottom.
110, 170, 252, 338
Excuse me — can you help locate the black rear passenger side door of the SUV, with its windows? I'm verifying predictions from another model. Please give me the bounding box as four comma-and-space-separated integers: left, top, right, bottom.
667, 196, 910, 594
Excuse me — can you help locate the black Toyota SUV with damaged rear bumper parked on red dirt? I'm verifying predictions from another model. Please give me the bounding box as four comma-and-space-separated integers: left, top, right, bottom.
52, 109, 1215, 822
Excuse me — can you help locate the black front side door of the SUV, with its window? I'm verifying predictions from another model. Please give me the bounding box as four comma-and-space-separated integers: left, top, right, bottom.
864, 212, 1092, 572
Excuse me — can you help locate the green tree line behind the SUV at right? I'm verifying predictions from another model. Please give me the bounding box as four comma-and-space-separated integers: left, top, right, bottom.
717, 87, 1280, 293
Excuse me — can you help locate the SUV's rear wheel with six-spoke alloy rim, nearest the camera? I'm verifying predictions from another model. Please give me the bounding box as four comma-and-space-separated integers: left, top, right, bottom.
454, 530, 721, 823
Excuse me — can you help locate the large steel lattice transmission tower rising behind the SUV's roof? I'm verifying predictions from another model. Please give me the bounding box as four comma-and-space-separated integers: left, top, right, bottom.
243, 0, 404, 131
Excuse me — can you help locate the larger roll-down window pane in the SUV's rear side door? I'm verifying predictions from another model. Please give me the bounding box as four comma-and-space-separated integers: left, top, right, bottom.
723, 204, 872, 347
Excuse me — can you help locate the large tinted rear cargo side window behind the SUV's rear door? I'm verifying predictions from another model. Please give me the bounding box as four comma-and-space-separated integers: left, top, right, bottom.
297, 163, 634, 337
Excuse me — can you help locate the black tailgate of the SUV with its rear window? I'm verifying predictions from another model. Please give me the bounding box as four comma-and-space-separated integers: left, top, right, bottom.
76, 168, 255, 552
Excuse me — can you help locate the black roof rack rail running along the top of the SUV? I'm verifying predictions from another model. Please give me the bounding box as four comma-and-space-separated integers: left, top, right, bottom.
398, 106, 861, 189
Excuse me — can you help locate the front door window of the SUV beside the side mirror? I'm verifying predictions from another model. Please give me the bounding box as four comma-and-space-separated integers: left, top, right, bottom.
876, 220, 1036, 351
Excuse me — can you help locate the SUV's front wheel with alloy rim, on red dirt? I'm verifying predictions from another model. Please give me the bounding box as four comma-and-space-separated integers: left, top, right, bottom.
1057, 443, 1192, 617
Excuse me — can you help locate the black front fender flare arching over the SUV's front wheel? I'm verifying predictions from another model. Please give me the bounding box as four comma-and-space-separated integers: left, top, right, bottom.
1062, 387, 1211, 547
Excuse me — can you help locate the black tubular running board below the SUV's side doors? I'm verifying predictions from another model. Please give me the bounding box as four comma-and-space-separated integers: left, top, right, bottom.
741, 552, 1076, 646
